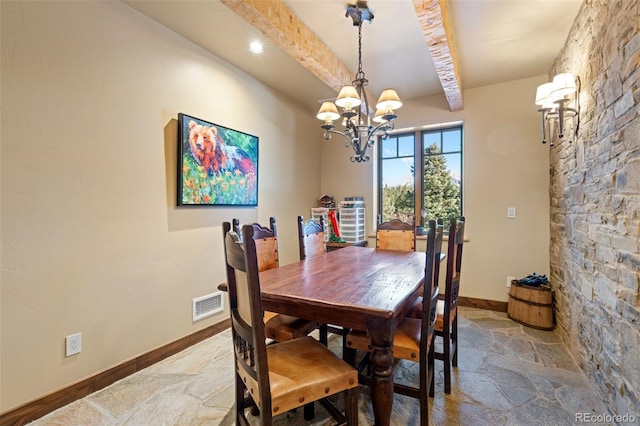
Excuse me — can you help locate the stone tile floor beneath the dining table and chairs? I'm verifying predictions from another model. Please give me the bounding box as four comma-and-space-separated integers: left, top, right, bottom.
31, 308, 607, 426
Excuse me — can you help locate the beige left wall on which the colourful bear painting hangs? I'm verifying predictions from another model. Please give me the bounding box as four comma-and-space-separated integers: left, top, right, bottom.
0, 1, 320, 412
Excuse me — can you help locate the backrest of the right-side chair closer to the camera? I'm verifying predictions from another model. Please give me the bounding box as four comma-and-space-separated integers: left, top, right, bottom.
420, 220, 443, 365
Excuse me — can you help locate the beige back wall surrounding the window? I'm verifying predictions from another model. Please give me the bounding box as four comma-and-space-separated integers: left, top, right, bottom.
321, 76, 549, 301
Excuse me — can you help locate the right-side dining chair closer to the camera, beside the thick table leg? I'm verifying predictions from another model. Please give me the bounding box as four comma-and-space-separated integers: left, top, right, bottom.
346, 220, 443, 426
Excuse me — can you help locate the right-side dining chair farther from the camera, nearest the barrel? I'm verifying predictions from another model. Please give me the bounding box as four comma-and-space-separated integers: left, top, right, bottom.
435, 217, 465, 393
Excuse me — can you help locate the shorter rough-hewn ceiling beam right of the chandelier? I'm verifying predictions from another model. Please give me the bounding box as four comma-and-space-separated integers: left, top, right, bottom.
413, 0, 464, 111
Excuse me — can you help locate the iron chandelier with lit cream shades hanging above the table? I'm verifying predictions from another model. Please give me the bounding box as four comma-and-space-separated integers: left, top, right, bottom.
317, 1, 402, 163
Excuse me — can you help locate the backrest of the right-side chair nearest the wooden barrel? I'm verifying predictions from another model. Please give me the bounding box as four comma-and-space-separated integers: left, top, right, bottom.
444, 217, 465, 324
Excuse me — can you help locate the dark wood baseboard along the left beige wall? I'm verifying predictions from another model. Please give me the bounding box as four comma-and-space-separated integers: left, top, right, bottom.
0, 319, 231, 426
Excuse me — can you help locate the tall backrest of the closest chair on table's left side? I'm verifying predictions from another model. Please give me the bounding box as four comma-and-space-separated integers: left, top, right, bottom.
222, 222, 271, 413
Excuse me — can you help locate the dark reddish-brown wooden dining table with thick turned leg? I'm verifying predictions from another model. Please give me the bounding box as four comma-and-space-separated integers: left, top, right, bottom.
260, 247, 425, 426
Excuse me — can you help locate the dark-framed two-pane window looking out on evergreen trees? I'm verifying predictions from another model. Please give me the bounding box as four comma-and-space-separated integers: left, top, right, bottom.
378, 126, 463, 225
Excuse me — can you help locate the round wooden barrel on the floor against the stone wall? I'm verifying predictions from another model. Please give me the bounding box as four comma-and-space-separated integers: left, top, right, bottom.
507, 280, 553, 330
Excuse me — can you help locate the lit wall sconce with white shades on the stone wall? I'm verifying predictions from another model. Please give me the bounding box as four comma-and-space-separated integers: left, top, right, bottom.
536, 72, 581, 146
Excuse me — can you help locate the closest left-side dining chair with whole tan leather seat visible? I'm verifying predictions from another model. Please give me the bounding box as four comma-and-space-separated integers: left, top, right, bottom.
222, 222, 358, 426
